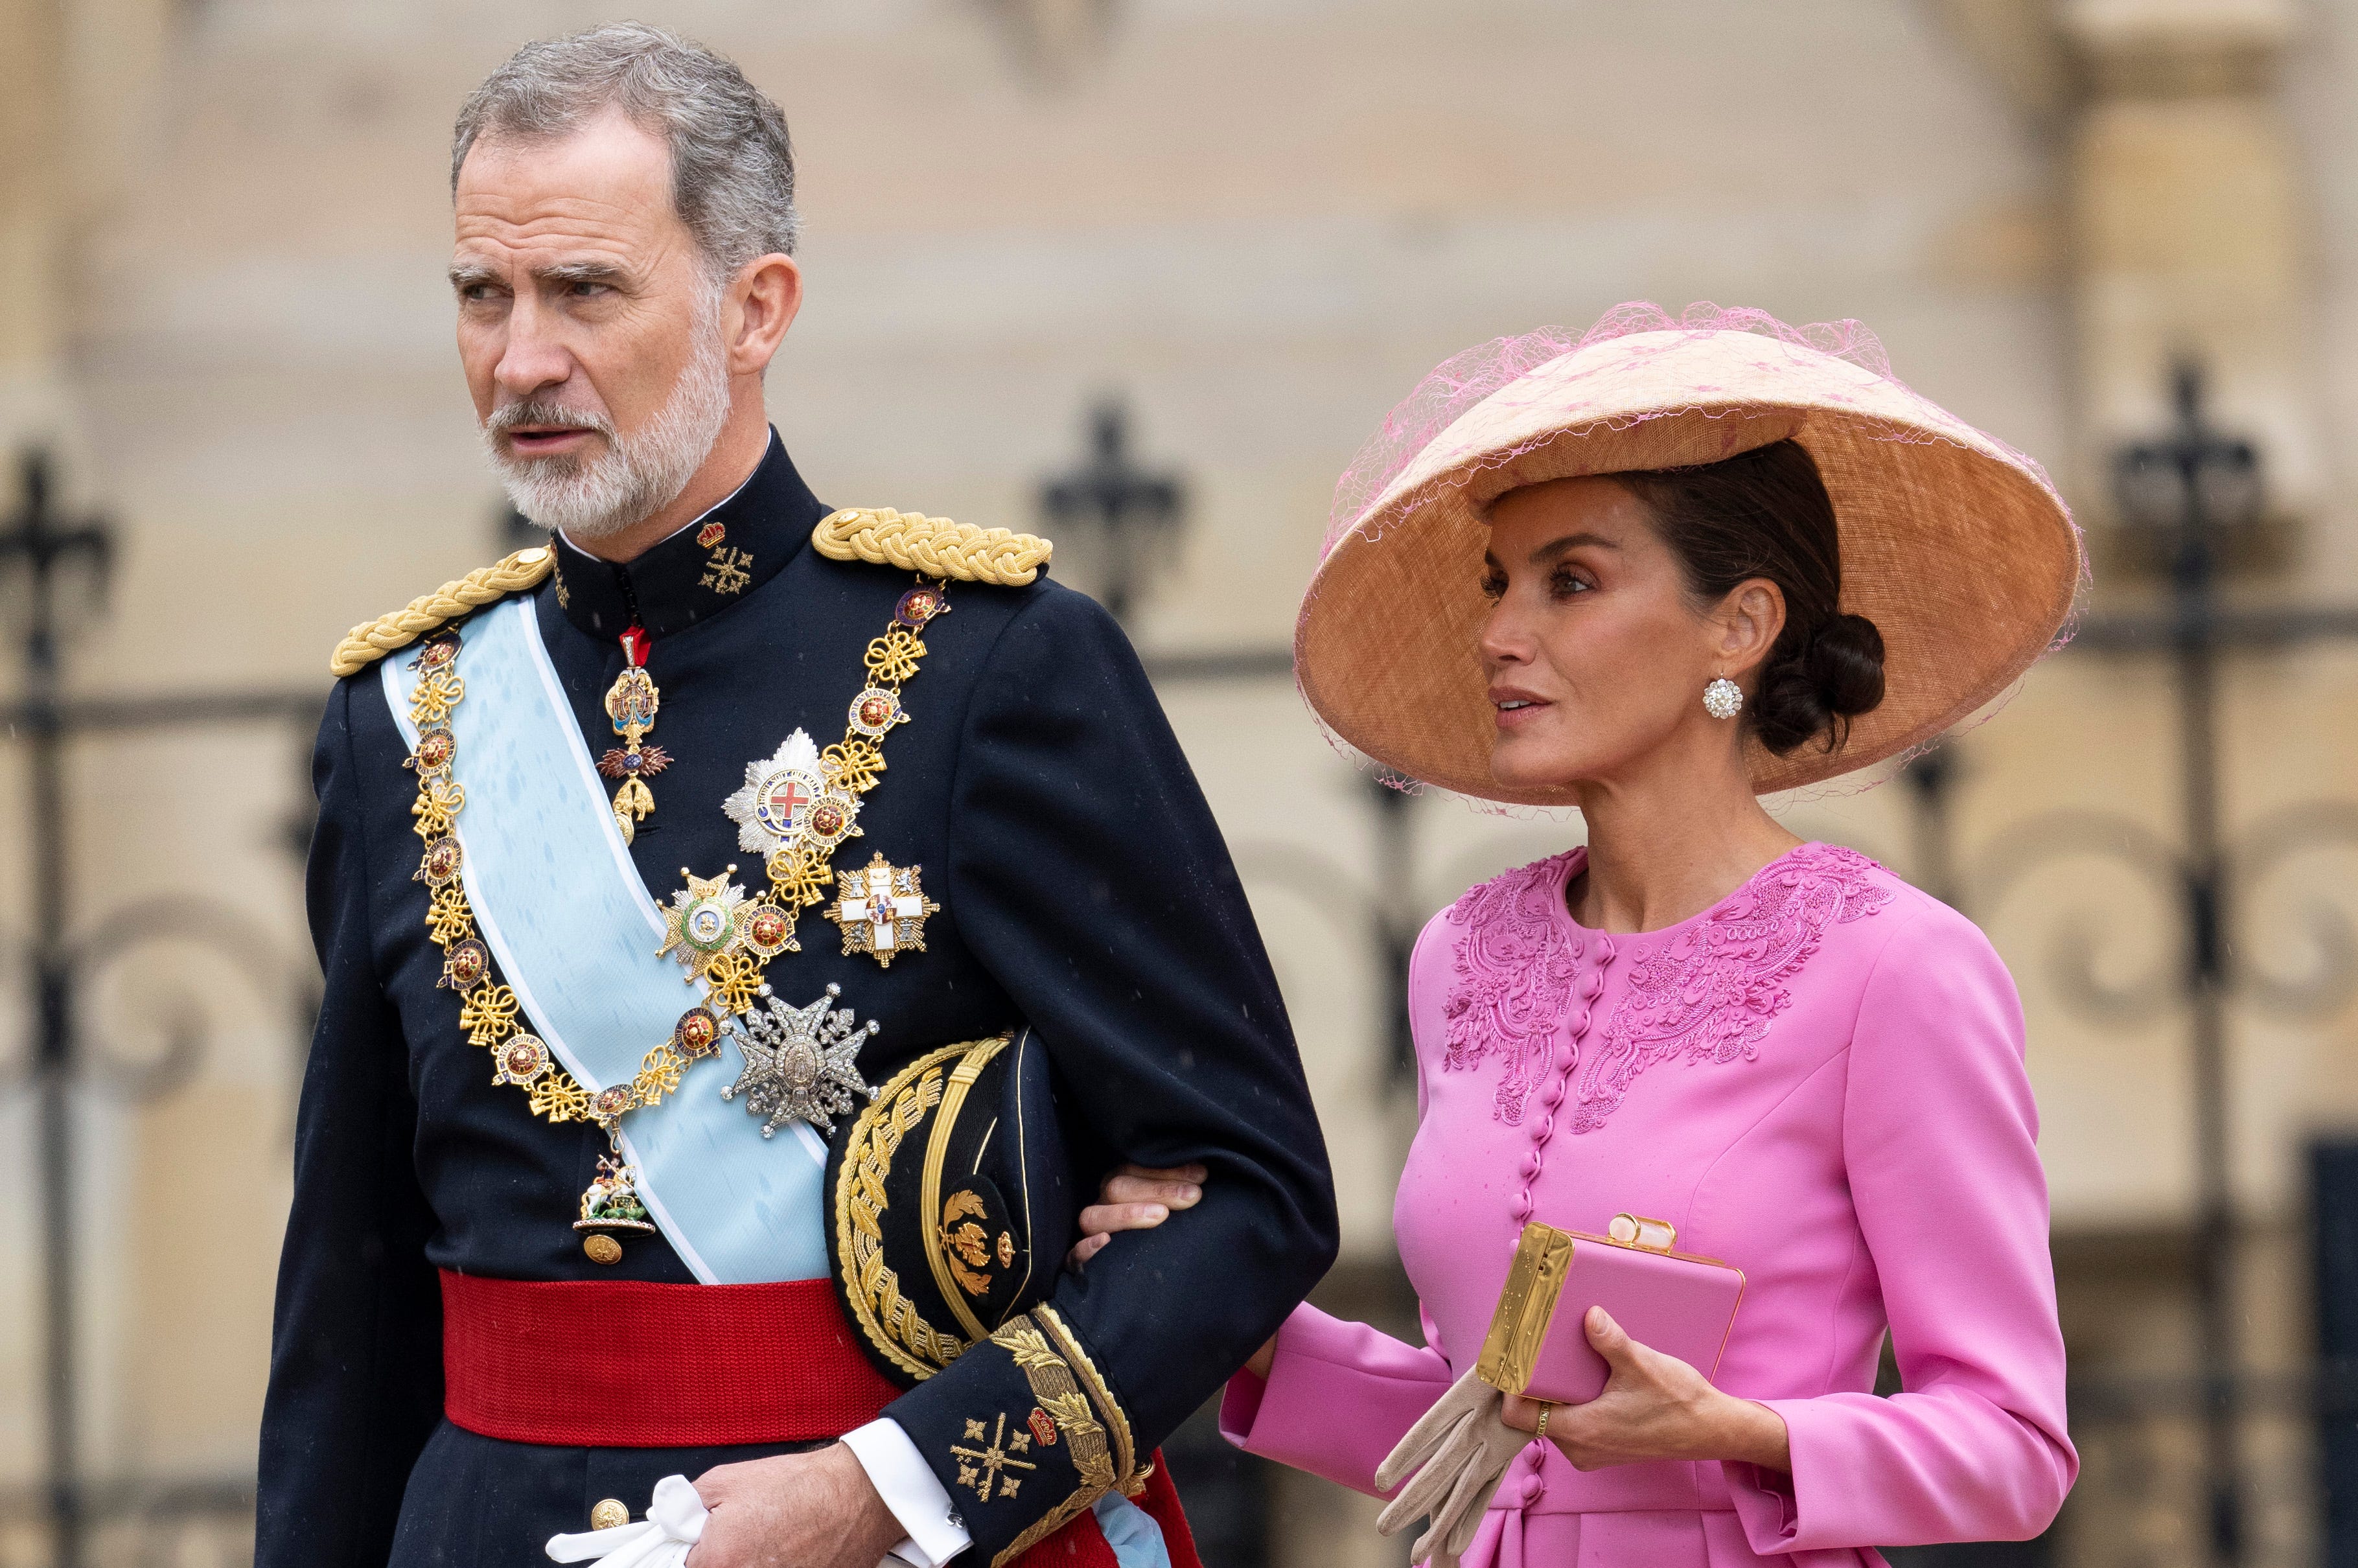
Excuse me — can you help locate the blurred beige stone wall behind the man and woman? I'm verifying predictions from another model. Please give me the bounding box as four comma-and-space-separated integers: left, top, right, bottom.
0, 0, 2358, 1568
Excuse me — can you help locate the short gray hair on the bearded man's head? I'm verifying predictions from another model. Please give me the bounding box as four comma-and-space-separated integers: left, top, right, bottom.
450, 21, 802, 278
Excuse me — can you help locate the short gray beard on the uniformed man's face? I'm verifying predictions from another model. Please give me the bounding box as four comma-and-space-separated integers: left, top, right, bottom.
483, 290, 728, 542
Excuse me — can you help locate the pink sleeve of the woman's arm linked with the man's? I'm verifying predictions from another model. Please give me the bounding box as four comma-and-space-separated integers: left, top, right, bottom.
1219, 1304, 1450, 1495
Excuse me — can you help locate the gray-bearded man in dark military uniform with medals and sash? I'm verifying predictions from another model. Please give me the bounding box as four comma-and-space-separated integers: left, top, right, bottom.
257, 23, 1335, 1568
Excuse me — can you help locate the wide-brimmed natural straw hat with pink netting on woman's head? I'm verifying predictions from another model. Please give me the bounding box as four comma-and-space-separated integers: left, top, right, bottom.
1295, 304, 2085, 807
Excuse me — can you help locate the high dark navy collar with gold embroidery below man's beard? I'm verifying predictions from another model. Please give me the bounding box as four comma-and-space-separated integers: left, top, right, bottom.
557, 429, 827, 641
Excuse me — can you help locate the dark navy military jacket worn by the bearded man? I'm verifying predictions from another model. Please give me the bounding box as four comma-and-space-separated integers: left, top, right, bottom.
255, 436, 1335, 1568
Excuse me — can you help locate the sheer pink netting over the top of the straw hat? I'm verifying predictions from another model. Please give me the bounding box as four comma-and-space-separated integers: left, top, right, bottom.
1323, 299, 1971, 549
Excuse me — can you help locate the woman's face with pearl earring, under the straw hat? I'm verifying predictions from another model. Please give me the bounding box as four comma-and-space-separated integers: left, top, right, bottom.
1481, 479, 1785, 787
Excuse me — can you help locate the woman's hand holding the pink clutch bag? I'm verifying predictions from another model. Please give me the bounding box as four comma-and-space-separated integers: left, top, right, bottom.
1499, 1306, 1792, 1471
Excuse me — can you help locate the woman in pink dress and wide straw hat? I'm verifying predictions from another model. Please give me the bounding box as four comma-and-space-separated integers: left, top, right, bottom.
1082, 306, 2082, 1568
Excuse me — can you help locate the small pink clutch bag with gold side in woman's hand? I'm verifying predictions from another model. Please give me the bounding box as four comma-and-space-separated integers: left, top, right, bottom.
1474, 1214, 1745, 1405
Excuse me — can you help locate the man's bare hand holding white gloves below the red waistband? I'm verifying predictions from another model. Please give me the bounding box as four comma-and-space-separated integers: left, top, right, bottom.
686, 1443, 908, 1568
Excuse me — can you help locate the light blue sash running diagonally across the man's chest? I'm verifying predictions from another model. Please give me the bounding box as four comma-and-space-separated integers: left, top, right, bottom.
384, 599, 827, 1285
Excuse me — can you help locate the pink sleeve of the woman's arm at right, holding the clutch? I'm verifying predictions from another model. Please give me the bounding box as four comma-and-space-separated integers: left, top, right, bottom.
1726, 905, 2080, 1554
